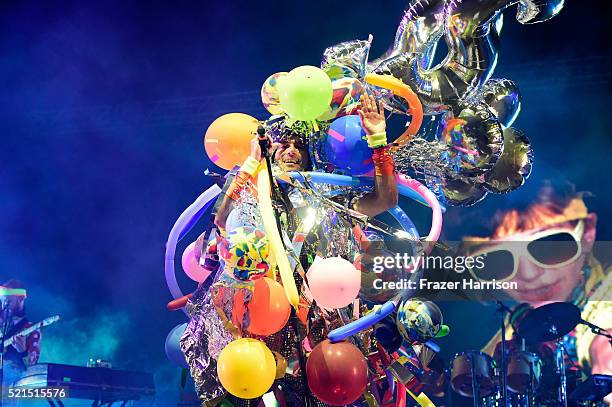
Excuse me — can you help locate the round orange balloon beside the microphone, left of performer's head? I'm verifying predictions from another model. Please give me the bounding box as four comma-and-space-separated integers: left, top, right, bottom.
204, 113, 259, 170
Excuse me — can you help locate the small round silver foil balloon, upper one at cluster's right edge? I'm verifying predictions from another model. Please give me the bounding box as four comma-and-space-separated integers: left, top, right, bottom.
480, 79, 522, 128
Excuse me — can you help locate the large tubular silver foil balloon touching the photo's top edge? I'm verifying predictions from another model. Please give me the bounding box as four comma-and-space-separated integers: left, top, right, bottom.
370, 0, 562, 114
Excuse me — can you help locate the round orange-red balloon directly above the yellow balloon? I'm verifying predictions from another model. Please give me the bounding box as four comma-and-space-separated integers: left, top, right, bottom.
246, 277, 291, 336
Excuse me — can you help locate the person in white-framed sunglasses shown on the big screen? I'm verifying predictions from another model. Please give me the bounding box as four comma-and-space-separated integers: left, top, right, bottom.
462, 182, 612, 402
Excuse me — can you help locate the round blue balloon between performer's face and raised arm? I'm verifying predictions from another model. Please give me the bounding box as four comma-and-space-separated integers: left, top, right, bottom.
322, 115, 374, 175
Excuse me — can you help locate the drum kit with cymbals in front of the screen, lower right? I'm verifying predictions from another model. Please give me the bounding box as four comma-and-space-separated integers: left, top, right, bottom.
425, 302, 612, 407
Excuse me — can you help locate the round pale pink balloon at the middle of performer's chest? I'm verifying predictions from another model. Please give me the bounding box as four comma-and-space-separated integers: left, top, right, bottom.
306, 257, 361, 308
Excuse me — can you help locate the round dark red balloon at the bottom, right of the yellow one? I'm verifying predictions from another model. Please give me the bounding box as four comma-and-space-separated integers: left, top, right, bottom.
306, 339, 368, 406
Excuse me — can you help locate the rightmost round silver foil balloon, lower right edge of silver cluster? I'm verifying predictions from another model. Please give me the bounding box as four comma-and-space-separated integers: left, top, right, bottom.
481, 128, 533, 194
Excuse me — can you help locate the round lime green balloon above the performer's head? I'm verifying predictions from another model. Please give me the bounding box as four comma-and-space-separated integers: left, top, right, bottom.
278, 65, 333, 121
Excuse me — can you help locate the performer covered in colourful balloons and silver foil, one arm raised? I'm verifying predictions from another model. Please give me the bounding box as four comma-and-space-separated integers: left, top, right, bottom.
166, 0, 562, 406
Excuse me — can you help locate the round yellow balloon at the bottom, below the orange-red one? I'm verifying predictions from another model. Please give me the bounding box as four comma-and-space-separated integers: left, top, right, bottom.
217, 338, 276, 399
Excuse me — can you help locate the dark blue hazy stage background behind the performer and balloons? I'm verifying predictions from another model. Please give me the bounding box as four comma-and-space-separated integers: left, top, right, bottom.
0, 0, 612, 406
